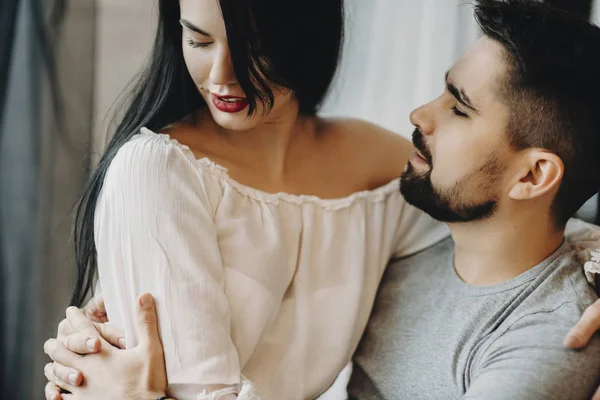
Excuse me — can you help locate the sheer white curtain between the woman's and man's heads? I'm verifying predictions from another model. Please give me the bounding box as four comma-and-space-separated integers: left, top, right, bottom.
322, 0, 477, 136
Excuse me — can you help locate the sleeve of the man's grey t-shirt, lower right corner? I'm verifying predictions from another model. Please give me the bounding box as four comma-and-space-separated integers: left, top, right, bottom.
463, 303, 600, 400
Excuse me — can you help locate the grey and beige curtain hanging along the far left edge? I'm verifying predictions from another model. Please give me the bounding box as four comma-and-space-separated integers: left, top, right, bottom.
0, 0, 96, 400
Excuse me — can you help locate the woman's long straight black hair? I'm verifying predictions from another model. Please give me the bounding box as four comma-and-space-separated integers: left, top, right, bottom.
70, 0, 343, 306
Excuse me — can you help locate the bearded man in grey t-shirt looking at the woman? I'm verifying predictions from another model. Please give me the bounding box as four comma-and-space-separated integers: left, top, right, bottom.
349, 0, 600, 400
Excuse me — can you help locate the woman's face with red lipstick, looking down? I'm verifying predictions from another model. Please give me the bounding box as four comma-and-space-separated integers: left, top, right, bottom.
180, 0, 297, 131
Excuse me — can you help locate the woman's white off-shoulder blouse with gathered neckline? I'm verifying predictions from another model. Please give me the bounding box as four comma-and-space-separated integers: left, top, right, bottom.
95, 129, 449, 400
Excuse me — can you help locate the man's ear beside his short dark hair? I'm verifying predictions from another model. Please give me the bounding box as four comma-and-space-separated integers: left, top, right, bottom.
508, 149, 565, 200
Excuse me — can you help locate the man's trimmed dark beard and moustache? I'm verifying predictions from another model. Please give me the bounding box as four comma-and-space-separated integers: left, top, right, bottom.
400, 130, 502, 223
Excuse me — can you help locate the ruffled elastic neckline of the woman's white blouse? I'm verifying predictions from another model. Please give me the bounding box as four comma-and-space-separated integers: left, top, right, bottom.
140, 127, 400, 210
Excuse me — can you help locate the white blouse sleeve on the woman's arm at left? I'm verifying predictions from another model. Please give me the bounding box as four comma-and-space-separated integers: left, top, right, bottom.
95, 135, 242, 400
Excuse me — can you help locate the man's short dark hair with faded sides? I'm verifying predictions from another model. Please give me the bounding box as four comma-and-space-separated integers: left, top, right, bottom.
475, 0, 600, 227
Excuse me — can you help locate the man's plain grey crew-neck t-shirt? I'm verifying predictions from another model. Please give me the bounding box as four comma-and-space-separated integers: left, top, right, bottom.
348, 239, 600, 400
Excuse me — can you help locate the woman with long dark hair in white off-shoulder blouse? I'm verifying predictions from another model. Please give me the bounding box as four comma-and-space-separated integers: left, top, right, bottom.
45, 0, 447, 399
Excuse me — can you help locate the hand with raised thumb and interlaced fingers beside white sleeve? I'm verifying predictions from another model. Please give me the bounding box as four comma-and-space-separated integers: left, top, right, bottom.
44, 294, 167, 400
